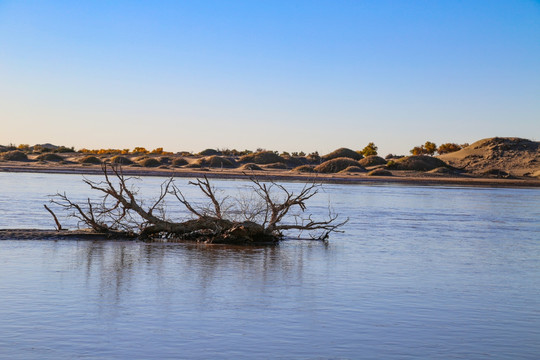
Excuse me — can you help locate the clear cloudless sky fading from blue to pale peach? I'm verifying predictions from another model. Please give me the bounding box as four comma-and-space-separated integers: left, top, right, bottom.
0, 0, 540, 156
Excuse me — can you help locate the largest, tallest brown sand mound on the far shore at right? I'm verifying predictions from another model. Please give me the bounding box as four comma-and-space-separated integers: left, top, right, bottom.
438, 137, 540, 176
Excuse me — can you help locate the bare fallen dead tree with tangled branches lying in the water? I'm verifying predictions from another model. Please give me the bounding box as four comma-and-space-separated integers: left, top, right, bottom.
48, 164, 347, 243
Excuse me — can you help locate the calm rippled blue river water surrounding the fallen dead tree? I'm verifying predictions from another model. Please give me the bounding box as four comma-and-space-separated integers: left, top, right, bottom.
0, 173, 540, 359
